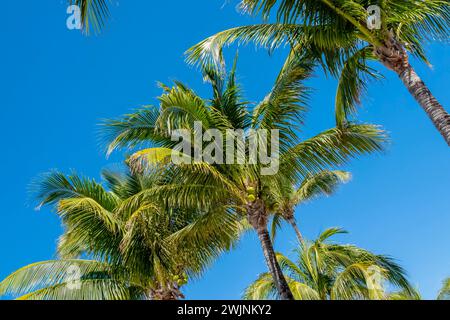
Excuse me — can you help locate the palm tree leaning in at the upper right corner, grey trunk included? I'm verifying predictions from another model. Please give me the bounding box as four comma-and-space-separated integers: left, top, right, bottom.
188, 0, 450, 145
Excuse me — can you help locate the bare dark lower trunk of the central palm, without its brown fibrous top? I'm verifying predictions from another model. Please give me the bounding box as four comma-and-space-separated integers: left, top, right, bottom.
256, 228, 294, 300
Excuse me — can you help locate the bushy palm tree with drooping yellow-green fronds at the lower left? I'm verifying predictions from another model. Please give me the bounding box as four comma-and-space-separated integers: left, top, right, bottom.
0, 166, 239, 300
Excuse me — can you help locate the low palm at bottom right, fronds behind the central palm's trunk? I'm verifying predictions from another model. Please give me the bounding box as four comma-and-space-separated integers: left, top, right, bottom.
244, 228, 414, 300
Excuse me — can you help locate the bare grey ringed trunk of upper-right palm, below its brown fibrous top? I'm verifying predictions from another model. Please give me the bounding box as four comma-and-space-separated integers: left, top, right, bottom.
398, 65, 450, 146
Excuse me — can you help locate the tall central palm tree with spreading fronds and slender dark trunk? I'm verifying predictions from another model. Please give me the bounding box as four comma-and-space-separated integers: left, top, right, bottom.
105, 53, 385, 299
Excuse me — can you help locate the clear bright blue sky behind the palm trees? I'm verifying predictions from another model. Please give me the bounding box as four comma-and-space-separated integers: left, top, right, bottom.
0, 0, 450, 299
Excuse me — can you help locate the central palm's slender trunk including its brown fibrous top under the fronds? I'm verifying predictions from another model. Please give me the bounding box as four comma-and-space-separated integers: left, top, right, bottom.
247, 199, 294, 300
